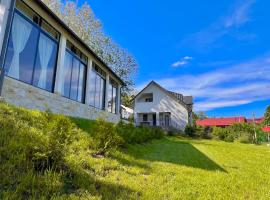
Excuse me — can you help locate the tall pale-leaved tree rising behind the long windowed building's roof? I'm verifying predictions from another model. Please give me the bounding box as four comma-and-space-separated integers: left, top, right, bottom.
43, 0, 138, 94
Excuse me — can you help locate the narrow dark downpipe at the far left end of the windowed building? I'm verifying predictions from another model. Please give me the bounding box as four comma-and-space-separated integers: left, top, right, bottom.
0, 0, 16, 96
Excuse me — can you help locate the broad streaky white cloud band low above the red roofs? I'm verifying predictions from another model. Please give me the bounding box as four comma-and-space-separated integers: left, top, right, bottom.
136, 55, 270, 111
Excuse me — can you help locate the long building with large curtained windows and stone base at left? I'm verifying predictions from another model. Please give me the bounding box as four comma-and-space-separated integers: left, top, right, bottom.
0, 0, 124, 122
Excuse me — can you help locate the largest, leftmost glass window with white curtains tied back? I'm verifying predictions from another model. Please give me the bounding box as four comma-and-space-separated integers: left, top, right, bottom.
5, 1, 58, 91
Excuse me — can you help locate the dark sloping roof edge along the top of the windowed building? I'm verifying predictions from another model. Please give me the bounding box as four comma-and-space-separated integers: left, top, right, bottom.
34, 0, 125, 85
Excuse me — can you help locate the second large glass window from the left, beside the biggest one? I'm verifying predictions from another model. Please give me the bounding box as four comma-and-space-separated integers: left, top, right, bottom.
62, 50, 86, 103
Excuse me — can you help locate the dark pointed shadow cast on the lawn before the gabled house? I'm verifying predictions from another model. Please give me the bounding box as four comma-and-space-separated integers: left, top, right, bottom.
119, 138, 227, 173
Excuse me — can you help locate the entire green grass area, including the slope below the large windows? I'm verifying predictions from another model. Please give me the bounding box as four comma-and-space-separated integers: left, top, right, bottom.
0, 104, 270, 200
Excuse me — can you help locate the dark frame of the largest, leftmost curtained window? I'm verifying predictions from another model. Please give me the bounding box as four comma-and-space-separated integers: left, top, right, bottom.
4, 7, 61, 93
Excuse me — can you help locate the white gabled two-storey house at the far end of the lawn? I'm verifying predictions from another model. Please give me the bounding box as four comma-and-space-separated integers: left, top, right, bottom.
134, 81, 193, 130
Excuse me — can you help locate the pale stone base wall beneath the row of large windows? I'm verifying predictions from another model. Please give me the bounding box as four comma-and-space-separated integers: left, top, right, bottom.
0, 77, 120, 123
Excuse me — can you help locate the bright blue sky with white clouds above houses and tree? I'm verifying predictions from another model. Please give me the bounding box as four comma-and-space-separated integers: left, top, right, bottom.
79, 0, 270, 117
